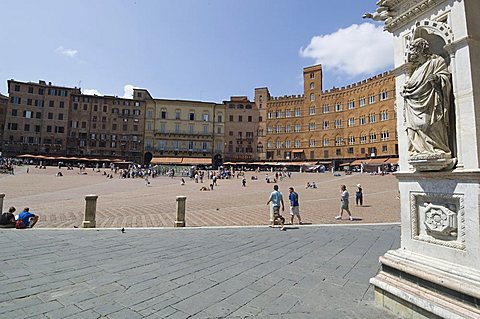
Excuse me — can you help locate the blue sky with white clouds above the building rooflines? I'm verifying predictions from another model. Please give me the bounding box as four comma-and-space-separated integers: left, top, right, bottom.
0, 0, 393, 102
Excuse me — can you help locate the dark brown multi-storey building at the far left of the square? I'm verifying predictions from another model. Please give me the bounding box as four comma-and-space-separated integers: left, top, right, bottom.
2, 80, 80, 156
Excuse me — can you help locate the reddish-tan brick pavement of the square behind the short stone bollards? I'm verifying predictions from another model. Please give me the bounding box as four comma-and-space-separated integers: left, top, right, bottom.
0, 167, 400, 227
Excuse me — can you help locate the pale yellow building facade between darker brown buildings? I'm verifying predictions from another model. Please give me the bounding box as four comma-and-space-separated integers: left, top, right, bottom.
134, 89, 225, 165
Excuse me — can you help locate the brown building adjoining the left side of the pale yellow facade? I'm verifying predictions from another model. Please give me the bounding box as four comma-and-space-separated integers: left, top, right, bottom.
66, 94, 145, 162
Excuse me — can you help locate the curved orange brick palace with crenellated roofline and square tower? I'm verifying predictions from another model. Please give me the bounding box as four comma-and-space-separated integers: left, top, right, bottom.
256, 65, 398, 163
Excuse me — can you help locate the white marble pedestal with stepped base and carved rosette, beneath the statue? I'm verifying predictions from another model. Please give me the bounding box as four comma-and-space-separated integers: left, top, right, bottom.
370, 171, 480, 318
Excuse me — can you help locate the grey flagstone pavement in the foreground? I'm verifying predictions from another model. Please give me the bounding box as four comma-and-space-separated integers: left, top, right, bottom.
0, 225, 400, 319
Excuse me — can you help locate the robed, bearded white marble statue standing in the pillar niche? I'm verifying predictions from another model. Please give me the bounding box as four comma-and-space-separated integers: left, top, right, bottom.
402, 38, 452, 165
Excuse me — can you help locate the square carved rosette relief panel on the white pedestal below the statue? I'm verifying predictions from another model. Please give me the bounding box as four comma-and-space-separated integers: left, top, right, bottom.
410, 192, 466, 250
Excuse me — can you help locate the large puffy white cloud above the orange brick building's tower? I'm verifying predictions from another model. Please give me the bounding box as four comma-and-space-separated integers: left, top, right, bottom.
300, 23, 393, 76
